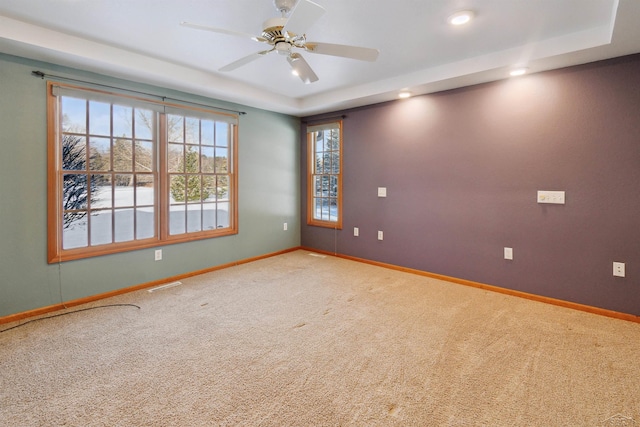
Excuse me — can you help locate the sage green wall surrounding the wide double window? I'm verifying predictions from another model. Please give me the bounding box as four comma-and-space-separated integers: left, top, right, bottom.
0, 54, 300, 317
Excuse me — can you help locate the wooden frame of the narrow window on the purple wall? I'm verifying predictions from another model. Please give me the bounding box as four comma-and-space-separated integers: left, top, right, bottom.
307, 120, 344, 230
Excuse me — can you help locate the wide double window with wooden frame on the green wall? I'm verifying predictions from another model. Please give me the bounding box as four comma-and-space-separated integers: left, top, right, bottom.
47, 82, 237, 262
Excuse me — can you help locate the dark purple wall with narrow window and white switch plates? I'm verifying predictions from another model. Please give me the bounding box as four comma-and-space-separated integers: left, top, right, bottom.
301, 55, 640, 315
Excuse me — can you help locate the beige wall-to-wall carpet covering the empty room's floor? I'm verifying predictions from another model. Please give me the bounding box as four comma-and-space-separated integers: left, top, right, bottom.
0, 251, 640, 426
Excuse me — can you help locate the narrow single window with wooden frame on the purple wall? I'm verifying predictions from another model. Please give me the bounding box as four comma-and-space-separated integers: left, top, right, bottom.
307, 121, 342, 229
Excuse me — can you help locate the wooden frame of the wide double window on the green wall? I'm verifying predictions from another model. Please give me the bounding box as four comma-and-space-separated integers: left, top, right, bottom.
47, 81, 238, 263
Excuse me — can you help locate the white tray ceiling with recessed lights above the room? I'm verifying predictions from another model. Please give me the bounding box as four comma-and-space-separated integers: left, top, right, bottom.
0, 0, 640, 116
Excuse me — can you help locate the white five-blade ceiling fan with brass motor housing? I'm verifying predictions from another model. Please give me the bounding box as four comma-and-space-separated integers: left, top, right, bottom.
180, 0, 379, 84
